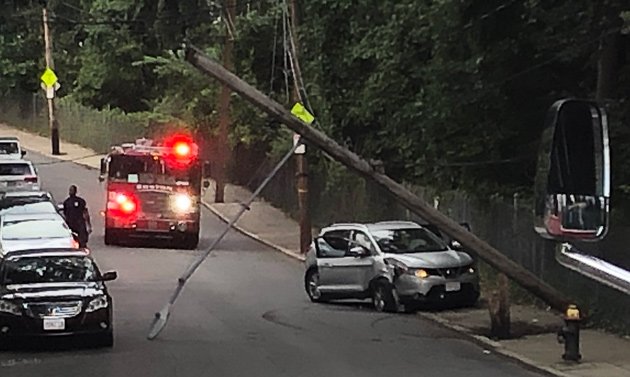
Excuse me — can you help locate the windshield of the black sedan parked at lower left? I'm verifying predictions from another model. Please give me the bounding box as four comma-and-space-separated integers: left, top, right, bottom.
2, 256, 98, 284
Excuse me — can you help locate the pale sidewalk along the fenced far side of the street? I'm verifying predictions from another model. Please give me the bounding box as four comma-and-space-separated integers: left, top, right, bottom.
0, 125, 630, 377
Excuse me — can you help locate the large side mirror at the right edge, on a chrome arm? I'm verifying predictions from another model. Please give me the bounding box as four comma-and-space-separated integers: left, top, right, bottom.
534, 99, 610, 241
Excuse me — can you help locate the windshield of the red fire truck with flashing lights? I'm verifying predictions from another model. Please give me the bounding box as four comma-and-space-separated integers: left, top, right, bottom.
108, 155, 201, 186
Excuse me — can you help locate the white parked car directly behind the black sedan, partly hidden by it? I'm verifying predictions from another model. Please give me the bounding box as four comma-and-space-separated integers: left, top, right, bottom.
0, 213, 79, 252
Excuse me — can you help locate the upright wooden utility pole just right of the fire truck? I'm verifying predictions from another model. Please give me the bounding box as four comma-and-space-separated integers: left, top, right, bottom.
214, 0, 236, 203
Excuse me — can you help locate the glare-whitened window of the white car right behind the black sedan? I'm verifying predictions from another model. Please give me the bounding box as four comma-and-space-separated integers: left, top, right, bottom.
2, 220, 72, 240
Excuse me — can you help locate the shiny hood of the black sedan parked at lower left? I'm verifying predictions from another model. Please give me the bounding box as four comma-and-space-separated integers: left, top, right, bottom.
0, 282, 105, 300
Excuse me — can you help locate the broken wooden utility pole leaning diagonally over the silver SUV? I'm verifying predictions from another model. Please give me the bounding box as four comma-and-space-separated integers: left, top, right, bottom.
186, 45, 569, 312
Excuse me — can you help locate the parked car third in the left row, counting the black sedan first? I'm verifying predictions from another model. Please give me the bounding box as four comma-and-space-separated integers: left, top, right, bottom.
0, 191, 58, 215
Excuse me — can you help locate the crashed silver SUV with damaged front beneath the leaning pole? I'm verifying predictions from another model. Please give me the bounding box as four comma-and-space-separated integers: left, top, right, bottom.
304, 221, 479, 312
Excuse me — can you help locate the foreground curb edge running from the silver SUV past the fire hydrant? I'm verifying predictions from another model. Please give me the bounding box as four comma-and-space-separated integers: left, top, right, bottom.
417, 312, 574, 377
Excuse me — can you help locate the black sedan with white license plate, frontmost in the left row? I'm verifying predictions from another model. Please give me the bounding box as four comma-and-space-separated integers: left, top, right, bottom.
0, 249, 117, 349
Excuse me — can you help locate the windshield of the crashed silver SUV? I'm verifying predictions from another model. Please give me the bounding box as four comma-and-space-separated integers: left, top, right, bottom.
372, 228, 448, 254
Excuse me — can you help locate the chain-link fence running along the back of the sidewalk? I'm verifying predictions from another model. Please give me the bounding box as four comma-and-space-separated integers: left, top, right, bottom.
0, 95, 630, 333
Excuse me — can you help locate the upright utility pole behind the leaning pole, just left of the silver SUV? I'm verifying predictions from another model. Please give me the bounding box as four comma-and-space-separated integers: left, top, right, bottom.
290, 0, 312, 254
